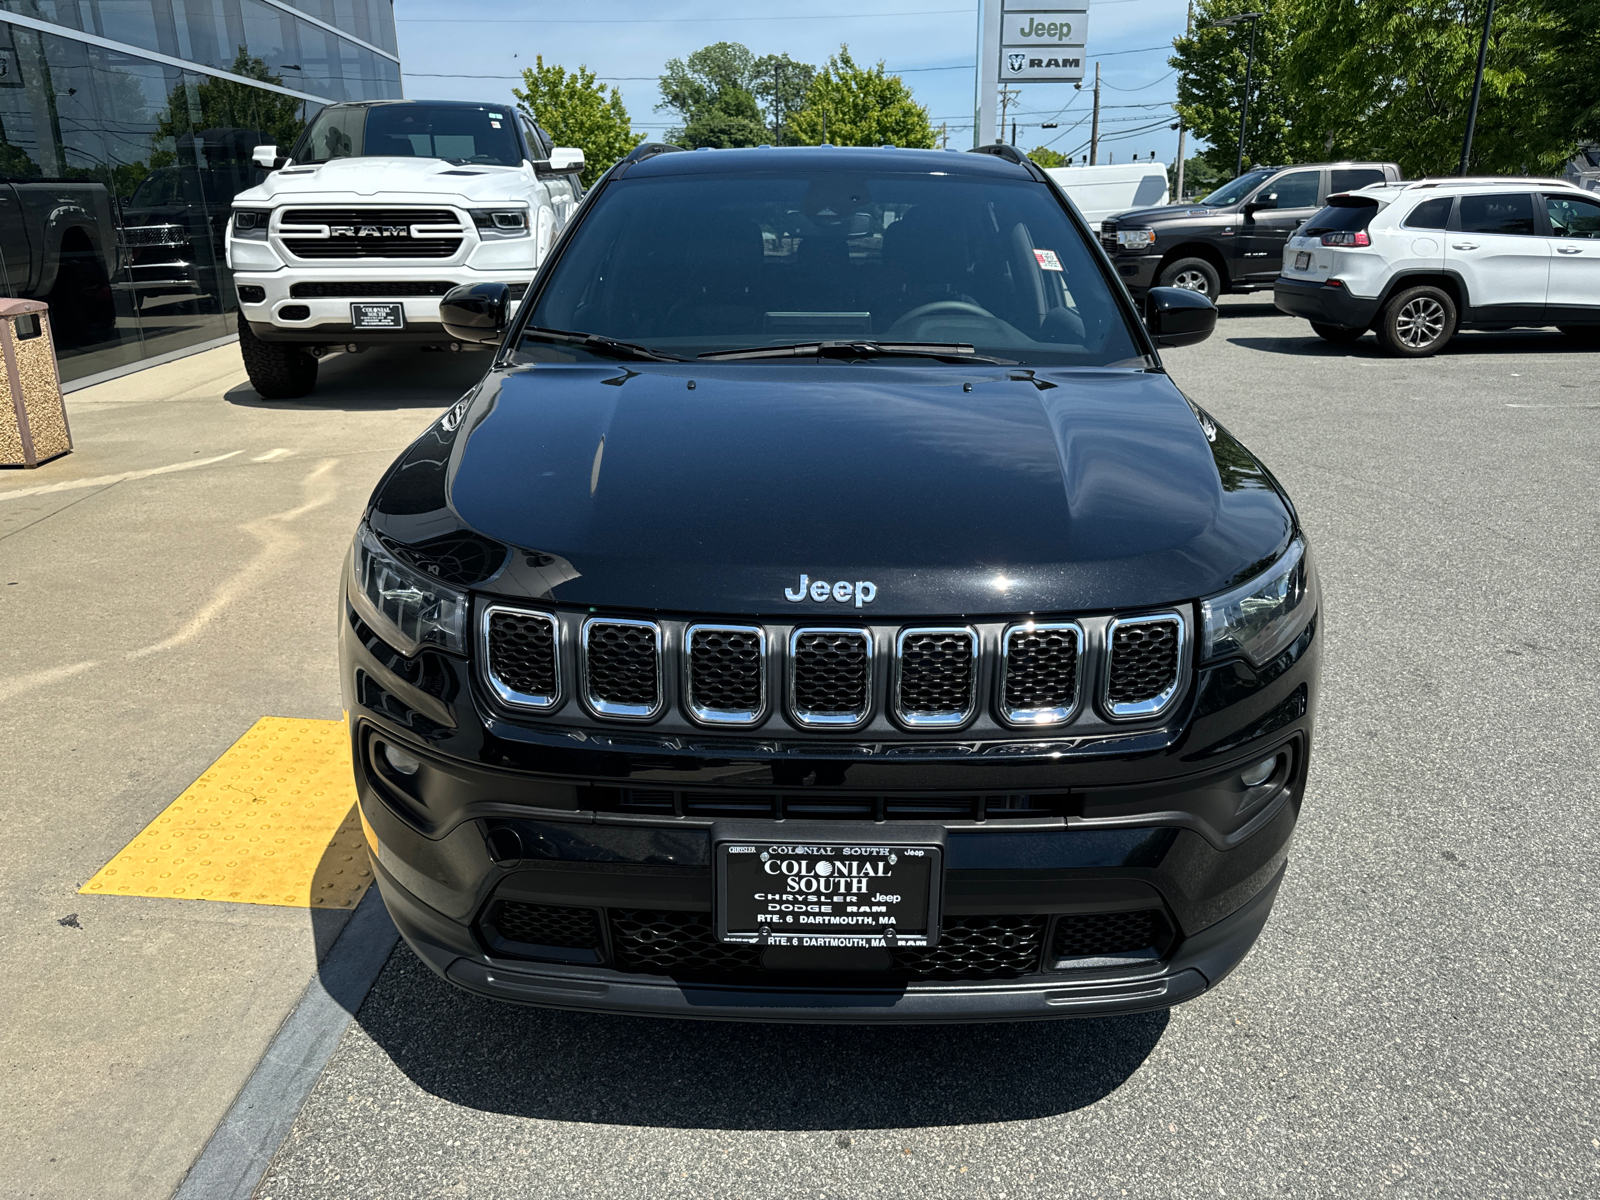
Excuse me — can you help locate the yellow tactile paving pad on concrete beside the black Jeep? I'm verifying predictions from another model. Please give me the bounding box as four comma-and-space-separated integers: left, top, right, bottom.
78, 717, 373, 909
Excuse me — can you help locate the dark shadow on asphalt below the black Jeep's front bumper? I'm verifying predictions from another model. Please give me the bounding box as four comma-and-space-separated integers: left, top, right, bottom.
357, 942, 1168, 1130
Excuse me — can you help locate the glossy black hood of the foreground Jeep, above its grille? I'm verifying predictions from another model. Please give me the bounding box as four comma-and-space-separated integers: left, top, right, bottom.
370, 363, 1294, 619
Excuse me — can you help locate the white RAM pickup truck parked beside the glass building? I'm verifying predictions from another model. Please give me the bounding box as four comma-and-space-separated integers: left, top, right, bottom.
227, 101, 584, 400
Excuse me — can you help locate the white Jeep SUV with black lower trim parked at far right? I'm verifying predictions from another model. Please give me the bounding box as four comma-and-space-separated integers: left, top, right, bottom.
1272, 176, 1600, 357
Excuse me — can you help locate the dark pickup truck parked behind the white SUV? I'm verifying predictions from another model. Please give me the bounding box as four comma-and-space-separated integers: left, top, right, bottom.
1099, 163, 1400, 298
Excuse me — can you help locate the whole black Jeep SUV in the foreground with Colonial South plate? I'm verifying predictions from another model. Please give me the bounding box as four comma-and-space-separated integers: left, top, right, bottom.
339, 147, 1320, 1021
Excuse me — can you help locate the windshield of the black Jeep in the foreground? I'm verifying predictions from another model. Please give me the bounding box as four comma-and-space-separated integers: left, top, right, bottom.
522, 168, 1142, 366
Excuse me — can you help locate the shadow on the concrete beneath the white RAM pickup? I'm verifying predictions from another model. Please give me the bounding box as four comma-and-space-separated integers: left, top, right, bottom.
227, 347, 494, 413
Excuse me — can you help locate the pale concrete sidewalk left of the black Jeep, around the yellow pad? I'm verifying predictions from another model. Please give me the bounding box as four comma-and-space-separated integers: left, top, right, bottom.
0, 346, 488, 1198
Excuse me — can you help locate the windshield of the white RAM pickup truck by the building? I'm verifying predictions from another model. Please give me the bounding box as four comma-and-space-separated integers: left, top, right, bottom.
294, 104, 522, 166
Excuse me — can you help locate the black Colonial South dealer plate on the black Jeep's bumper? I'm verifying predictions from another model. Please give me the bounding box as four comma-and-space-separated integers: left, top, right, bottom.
717, 842, 942, 947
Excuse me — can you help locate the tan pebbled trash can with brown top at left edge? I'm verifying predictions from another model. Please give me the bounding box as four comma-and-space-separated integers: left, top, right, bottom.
0, 299, 72, 467
